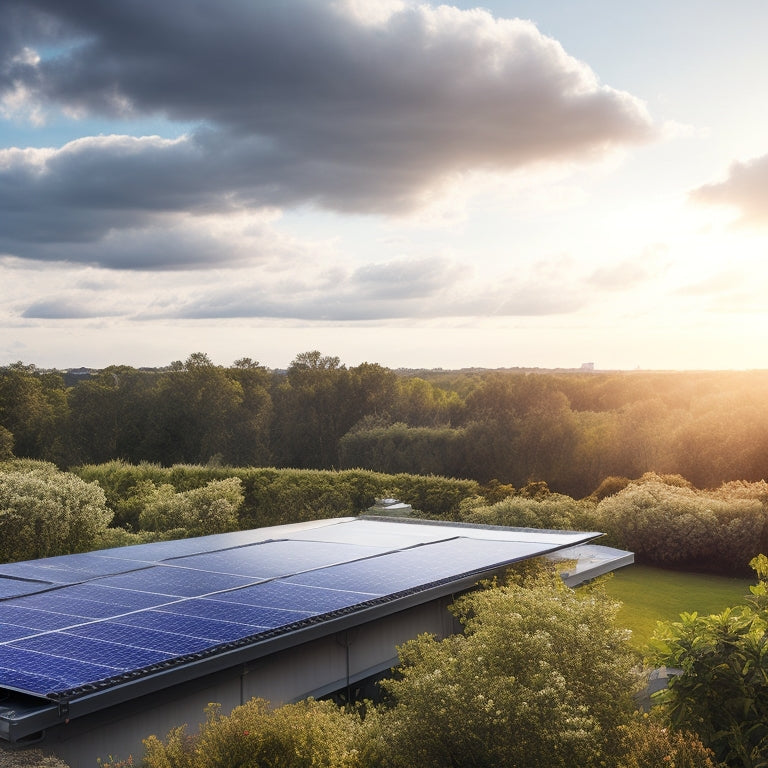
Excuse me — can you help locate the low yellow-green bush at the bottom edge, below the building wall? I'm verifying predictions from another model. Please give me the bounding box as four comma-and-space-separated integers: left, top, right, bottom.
142, 699, 361, 768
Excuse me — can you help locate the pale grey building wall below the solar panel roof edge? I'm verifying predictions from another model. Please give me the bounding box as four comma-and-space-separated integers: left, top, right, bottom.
30, 598, 459, 768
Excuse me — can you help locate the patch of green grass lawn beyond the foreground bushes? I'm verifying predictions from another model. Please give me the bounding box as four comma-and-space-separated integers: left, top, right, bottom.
606, 565, 756, 651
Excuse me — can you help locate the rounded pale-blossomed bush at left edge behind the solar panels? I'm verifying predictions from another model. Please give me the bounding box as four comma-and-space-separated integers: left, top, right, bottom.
0, 461, 112, 562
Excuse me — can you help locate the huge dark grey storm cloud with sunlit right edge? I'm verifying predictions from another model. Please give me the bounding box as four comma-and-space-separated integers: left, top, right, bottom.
0, 0, 654, 269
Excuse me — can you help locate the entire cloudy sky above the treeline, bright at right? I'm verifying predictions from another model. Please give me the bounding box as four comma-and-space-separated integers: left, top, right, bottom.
0, 0, 768, 370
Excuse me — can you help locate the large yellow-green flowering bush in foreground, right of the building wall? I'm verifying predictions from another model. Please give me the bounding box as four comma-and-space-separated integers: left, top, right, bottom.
379, 574, 633, 768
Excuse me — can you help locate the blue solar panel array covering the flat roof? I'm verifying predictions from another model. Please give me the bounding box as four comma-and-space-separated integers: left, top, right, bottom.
0, 519, 596, 699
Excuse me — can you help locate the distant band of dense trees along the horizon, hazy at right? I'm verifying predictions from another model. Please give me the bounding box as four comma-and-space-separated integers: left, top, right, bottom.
0, 351, 768, 498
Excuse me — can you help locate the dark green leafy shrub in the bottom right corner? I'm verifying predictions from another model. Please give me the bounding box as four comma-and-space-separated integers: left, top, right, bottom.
649, 555, 768, 768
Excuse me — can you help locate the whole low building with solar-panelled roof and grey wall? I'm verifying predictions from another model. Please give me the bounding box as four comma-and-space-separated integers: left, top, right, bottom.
0, 516, 631, 768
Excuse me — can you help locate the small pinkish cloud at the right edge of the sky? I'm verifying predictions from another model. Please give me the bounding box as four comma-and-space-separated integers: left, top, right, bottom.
691, 155, 768, 225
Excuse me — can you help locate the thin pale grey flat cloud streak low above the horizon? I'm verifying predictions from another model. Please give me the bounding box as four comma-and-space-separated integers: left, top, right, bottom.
132, 258, 585, 323
